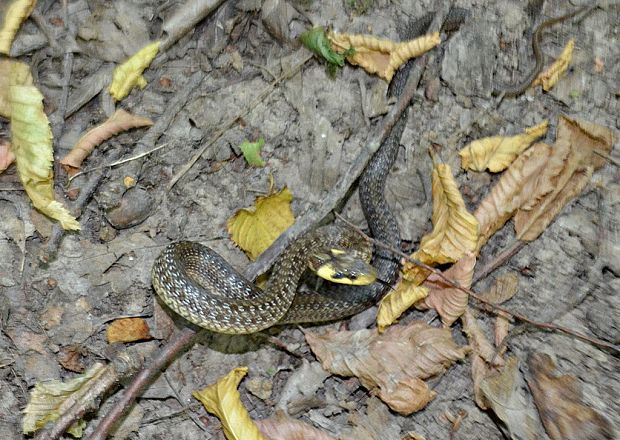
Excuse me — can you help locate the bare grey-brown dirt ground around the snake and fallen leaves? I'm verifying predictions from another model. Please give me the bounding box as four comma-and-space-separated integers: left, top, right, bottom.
0, 0, 620, 440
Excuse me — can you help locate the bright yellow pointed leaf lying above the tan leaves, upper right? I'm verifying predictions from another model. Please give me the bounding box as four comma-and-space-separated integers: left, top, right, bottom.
459, 120, 549, 173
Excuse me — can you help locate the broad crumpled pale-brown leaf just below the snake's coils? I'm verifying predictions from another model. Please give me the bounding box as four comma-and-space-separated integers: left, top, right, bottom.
306, 321, 468, 415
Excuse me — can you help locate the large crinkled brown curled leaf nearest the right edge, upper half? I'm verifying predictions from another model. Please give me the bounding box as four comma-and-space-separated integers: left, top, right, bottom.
515, 116, 615, 241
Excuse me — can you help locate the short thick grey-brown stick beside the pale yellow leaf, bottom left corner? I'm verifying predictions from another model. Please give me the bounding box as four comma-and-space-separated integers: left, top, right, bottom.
35, 350, 143, 440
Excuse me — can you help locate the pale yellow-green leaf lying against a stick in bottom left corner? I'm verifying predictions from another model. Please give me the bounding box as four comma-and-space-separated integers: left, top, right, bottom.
22, 363, 106, 437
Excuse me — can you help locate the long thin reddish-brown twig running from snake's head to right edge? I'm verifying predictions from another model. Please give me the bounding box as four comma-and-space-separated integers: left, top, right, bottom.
334, 213, 620, 353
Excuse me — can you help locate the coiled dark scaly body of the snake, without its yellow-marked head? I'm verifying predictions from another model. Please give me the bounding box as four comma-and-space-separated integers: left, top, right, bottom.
151, 8, 467, 334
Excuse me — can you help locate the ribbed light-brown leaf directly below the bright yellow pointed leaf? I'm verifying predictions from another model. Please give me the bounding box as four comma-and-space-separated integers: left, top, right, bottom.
474, 143, 551, 250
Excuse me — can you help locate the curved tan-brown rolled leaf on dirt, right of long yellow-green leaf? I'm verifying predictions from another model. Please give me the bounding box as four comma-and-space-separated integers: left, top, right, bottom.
60, 109, 153, 176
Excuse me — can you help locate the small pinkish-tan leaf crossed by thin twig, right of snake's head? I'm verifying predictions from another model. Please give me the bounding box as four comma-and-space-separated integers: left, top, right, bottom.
417, 253, 476, 327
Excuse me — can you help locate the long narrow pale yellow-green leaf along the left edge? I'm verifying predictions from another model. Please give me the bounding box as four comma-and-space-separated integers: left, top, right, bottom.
9, 63, 80, 230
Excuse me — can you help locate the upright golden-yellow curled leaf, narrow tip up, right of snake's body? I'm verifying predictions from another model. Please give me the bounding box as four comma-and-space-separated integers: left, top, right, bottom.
403, 164, 478, 281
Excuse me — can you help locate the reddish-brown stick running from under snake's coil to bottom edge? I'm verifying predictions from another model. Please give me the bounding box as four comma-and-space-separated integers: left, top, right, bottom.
89, 327, 197, 440
